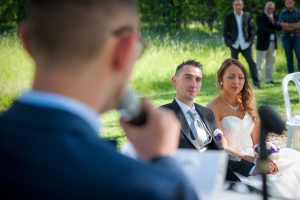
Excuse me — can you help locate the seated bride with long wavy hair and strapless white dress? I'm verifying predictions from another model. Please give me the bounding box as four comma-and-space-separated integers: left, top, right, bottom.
208, 58, 300, 199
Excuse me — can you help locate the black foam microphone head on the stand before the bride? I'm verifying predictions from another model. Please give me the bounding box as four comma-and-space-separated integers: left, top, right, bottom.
258, 105, 286, 134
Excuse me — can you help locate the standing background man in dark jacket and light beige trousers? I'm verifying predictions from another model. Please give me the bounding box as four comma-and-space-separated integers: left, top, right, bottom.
256, 1, 281, 84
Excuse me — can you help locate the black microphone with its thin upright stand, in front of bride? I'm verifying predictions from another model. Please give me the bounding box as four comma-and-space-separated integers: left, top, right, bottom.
258, 106, 285, 200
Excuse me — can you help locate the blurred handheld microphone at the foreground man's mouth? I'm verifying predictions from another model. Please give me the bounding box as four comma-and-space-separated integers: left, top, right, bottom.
116, 87, 147, 126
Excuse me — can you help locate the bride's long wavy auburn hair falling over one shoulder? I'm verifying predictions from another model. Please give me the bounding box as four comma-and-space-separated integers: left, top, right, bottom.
216, 58, 258, 122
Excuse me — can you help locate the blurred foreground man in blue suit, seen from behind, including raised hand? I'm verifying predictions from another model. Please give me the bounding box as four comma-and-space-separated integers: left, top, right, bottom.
0, 0, 197, 200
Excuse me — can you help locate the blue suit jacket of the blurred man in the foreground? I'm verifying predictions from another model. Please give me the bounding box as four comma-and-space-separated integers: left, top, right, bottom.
0, 102, 197, 200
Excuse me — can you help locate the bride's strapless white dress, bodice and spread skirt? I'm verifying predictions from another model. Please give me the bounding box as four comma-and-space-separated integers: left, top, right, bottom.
221, 113, 300, 199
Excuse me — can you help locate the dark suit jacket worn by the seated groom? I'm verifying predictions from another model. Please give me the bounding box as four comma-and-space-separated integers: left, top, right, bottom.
161, 99, 254, 181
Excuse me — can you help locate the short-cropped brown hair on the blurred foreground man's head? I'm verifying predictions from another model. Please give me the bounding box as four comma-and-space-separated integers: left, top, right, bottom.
25, 0, 136, 65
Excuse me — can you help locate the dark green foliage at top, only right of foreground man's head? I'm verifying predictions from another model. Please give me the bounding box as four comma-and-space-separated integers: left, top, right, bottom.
138, 0, 284, 30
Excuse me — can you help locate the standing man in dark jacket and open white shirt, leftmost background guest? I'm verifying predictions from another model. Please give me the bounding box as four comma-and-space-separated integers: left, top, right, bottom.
223, 0, 260, 88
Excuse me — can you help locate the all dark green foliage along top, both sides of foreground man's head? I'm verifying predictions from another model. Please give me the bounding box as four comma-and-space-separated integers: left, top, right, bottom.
0, 0, 290, 32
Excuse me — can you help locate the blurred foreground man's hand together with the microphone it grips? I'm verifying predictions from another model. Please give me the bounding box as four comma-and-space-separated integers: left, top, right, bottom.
117, 90, 180, 160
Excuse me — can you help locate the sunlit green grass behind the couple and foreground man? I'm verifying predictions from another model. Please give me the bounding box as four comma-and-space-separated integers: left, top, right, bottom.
0, 26, 300, 145
